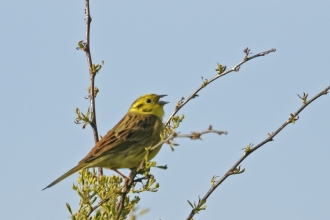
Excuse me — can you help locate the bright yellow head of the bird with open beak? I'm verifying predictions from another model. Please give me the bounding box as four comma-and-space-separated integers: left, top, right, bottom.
128, 94, 168, 119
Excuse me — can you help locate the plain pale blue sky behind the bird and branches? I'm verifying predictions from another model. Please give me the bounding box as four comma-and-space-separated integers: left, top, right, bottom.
0, 0, 330, 220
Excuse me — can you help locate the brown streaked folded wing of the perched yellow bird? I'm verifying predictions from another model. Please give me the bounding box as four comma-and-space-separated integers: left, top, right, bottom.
79, 114, 162, 163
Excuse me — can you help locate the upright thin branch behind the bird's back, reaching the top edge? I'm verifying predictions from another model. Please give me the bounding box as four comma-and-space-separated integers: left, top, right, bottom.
84, 0, 103, 176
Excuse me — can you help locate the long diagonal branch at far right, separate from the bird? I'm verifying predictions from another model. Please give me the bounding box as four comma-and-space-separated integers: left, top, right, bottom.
187, 86, 330, 220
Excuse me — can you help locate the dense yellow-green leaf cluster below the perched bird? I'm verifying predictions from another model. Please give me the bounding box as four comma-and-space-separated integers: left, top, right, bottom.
66, 169, 159, 220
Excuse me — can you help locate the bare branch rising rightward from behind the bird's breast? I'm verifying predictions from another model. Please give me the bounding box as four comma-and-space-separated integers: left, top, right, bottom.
165, 48, 276, 126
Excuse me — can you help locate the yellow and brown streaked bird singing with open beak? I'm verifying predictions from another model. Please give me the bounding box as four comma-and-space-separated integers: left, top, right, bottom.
44, 94, 168, 189
